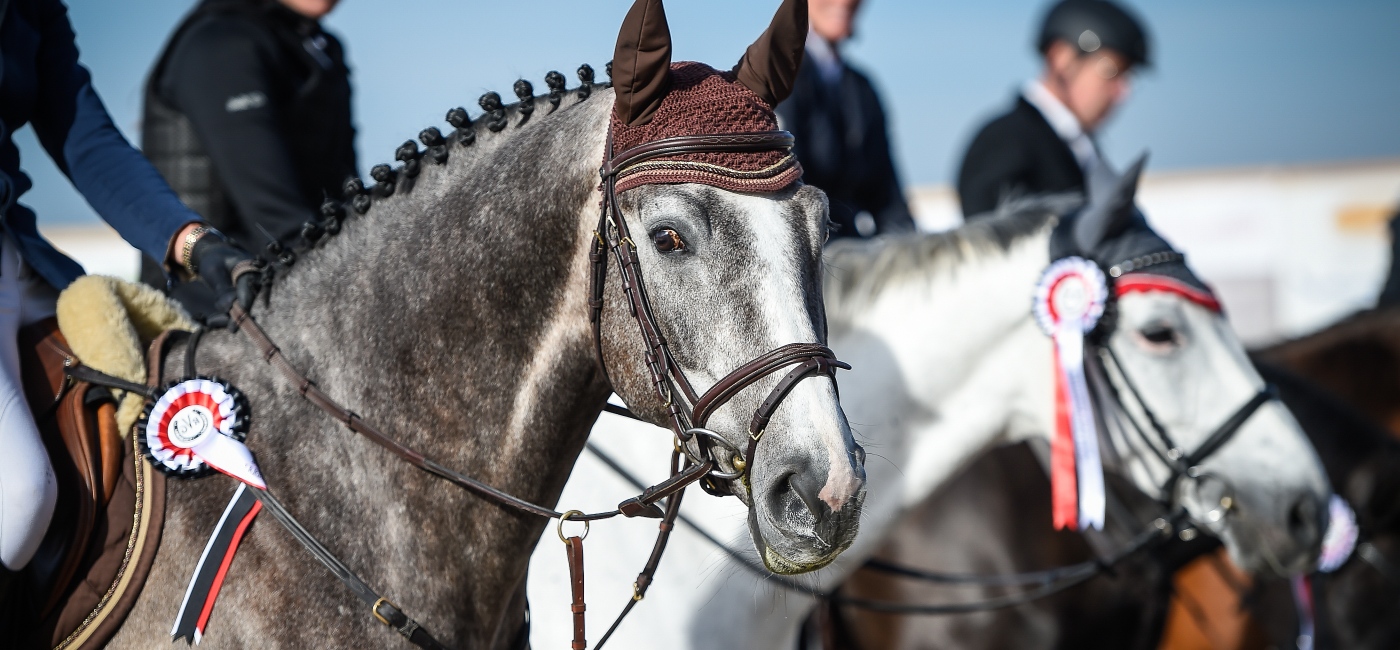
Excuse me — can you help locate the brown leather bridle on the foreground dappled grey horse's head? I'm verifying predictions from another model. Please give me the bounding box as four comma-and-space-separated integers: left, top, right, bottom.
588, 130, 850, 495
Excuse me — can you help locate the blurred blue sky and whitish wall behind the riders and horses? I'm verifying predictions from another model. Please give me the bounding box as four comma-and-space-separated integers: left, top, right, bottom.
15, 0, 1400, 343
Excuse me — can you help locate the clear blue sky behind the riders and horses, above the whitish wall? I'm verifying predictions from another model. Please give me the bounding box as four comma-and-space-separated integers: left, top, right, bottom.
17, 0, 1400, 223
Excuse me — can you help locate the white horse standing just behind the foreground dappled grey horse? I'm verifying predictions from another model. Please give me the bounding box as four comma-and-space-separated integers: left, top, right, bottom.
531, 158, 1329, 649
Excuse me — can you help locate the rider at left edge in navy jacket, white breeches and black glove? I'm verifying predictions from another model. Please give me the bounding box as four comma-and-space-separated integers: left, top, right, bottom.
0, 0, 256, 579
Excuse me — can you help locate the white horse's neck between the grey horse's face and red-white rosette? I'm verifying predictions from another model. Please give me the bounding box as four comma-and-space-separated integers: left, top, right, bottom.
832, 217, 1053, 518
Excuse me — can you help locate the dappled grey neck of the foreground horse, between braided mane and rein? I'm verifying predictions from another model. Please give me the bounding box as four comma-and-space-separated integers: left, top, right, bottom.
229, 91, 612, 503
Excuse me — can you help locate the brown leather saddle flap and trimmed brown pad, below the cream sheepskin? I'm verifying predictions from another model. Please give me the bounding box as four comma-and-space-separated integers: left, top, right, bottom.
17, 319, 167, 649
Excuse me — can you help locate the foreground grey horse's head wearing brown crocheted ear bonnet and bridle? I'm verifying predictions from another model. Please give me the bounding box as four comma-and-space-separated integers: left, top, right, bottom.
598, 0, 864, 573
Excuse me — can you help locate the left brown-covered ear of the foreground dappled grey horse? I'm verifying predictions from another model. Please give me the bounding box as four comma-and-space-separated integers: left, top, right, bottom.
612, 0, 671, 126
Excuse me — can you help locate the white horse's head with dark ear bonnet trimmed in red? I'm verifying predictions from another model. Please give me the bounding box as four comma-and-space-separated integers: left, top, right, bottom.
1075, 160, 1329, 573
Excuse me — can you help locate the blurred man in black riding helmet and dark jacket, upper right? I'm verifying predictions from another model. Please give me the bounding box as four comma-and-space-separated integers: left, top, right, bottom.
958, 0, 1149, 217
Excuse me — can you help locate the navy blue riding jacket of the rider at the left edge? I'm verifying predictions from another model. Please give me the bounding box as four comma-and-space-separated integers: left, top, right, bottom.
0, 0, 200, 289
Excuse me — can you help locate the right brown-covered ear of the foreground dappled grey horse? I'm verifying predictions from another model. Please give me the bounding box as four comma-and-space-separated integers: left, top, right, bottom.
734, 0, 808, 106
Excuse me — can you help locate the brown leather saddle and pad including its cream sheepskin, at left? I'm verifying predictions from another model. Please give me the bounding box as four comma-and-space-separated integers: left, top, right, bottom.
0, 276, 195, 650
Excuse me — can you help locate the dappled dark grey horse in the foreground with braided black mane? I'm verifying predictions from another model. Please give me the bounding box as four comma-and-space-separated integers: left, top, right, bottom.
111, 3, 864, 649
